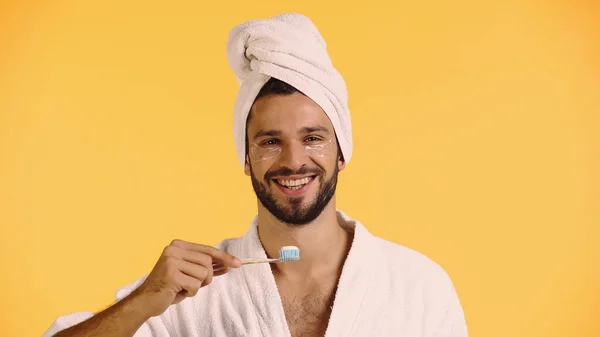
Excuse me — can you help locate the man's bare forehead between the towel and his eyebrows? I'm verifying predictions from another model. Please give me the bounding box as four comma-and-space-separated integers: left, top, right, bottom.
248, 93, 334, 136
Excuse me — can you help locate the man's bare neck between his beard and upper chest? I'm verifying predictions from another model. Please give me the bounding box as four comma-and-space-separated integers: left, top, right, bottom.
258, 197, 352, 278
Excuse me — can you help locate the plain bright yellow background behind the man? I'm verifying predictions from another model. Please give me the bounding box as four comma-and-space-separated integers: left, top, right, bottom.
0, 0, 600, 337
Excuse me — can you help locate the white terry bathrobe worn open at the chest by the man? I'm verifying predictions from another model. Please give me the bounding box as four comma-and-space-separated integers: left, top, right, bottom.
43, 211, 467, 337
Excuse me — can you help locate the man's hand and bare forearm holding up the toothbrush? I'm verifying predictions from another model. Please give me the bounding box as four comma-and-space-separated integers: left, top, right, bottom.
55, 240, 241, 337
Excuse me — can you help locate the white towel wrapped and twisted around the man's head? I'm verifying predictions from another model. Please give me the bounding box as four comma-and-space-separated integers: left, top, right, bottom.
227, 13, 352, 166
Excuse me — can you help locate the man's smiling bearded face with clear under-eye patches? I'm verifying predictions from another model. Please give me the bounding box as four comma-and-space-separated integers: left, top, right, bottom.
245, 93, 345, 225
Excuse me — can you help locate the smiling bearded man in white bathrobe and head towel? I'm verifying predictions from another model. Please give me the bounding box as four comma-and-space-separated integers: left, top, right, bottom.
44, 14, 467, 337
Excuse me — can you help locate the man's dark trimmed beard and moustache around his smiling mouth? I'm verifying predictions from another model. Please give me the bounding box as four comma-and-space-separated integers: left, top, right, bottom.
250, 165, 339, 227
